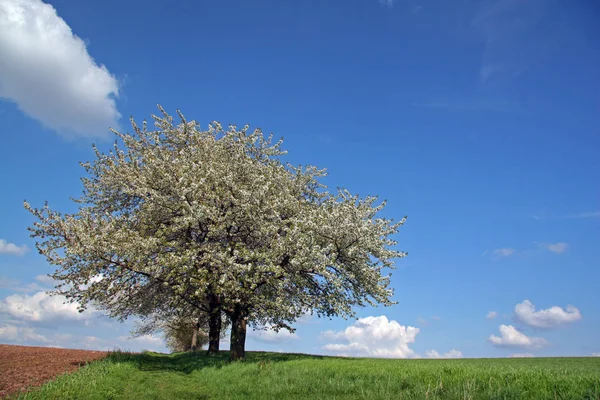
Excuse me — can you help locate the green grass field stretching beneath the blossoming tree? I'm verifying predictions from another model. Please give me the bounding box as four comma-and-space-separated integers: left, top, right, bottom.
13, 352, 600, 400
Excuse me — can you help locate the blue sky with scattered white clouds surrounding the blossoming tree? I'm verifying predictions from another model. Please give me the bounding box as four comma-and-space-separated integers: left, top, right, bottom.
0, 0, 600, 357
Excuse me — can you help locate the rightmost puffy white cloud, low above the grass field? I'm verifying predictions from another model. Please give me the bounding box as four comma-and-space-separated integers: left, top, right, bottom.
515, 300, 581, 328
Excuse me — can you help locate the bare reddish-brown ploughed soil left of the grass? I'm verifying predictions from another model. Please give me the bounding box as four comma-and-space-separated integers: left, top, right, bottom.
0, 344, 107, 397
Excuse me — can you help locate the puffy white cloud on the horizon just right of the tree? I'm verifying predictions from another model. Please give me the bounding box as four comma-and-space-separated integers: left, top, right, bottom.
322, 315, 419, 358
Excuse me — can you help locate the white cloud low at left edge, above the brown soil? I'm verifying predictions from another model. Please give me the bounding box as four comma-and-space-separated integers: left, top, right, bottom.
0, 292, 96, 324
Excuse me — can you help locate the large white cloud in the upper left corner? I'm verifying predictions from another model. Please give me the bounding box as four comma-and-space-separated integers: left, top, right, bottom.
0, 0, 120, 137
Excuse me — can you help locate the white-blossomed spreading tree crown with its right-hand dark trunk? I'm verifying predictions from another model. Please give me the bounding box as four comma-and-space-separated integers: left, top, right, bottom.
25, 106, 406, 359
